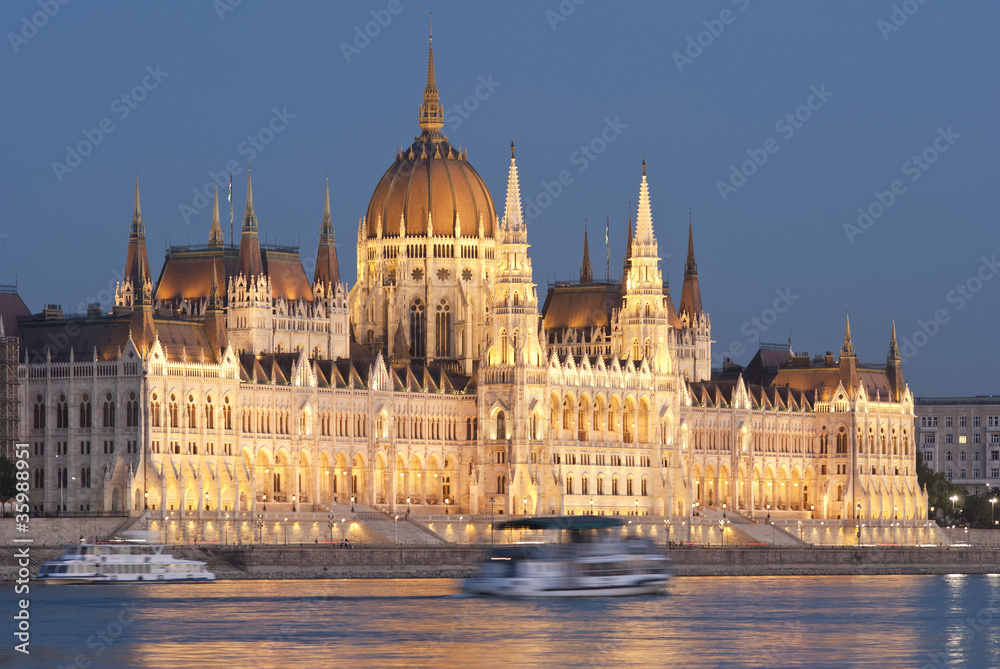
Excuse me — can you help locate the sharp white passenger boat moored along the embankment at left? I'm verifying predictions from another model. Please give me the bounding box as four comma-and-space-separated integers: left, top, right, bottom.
38, 542, 215, 585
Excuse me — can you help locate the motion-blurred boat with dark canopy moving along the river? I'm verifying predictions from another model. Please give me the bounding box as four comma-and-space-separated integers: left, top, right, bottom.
463, 516, 671, 597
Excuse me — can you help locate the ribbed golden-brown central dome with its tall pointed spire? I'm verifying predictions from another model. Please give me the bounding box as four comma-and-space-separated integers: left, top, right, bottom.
365, 38, 496, 239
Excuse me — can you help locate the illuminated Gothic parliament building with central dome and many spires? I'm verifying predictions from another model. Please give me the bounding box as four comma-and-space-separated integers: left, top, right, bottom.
11, 40, 926, 532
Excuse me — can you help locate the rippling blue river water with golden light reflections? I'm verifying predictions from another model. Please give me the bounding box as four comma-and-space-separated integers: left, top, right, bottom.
7, 575, 1000, 669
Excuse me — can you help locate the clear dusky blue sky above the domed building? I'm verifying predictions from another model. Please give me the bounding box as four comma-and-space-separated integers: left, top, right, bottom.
0, 0, 1000, 396
